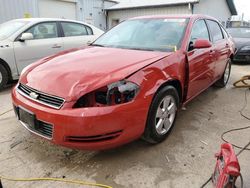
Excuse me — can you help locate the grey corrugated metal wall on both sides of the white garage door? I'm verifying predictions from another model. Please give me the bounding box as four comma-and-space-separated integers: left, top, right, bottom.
0, 0, 115, 30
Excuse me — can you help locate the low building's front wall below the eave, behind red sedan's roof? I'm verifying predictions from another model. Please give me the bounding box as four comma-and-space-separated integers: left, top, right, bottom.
108, 5, 192, 28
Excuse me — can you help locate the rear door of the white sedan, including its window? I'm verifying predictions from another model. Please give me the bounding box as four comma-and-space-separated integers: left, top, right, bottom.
61, 22, 95, 49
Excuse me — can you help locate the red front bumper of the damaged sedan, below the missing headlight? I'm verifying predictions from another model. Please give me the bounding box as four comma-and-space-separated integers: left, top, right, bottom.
12, 88, 151, 150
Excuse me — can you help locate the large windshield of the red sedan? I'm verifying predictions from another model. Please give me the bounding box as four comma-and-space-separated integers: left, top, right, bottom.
92, 19, 188, 52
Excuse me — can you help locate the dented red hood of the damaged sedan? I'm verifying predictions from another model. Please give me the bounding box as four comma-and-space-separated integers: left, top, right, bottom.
21, 47, 170, 101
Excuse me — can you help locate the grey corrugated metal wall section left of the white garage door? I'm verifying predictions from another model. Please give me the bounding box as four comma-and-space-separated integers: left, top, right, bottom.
0, 0, 38, 23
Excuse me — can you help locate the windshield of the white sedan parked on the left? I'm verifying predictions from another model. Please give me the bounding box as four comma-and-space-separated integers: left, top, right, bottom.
0, 20, 28, 40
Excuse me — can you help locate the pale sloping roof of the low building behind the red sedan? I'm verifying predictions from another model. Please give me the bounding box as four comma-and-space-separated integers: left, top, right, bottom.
107, 0, 199, 10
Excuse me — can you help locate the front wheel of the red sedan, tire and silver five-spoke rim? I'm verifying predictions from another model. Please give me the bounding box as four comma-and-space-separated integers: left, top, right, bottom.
142, 86, 179, 144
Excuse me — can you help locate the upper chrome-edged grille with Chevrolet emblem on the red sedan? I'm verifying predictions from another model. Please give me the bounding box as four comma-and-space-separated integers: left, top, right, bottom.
17, 83, 65, 109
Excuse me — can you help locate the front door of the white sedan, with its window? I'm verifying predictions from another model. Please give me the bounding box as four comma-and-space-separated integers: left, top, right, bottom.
14, 22, 63, 74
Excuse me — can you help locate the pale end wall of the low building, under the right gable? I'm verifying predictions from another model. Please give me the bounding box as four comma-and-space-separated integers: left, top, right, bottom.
193, 0, 232, 23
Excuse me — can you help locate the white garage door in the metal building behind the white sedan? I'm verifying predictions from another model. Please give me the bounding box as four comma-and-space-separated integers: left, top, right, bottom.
39, 0, 76, 20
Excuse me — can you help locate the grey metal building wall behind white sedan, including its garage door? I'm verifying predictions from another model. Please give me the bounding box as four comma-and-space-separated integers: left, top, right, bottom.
0, 0, 115, 30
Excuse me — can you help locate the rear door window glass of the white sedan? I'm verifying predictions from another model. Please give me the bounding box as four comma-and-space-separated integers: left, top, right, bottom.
62, 22, 88, 37
